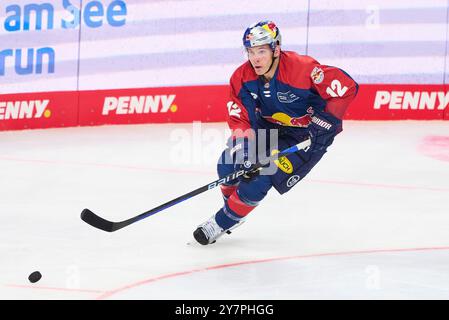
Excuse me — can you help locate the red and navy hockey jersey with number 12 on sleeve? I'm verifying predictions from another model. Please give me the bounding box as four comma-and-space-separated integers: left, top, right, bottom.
228, 51, 358, 136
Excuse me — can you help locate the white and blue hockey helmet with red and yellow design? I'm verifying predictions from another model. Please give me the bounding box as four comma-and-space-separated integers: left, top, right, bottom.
243, 20, 281, 50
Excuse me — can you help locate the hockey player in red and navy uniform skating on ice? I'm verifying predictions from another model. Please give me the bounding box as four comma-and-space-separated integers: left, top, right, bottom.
193, 21, 358, 245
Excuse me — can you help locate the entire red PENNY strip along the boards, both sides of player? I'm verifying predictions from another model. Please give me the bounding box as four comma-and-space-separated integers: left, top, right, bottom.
0, 85, 449, 130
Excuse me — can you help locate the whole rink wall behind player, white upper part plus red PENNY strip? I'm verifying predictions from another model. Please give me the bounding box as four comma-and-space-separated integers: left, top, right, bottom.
0, 0, 449, 130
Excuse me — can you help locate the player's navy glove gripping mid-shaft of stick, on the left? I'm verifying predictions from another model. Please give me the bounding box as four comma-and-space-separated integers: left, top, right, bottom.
227, 137, 259, 181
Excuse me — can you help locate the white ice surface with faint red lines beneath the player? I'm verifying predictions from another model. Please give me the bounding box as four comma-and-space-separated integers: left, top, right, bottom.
0, 121, 449, 300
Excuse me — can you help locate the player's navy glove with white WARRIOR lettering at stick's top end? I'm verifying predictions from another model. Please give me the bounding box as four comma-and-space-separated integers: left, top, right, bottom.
308, 112, 342, 152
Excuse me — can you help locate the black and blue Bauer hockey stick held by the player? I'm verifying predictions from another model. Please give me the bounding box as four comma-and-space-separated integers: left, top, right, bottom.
81, 139, 311, 232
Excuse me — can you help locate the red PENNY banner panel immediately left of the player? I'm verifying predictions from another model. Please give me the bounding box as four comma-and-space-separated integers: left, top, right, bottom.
79, 86, 229, 125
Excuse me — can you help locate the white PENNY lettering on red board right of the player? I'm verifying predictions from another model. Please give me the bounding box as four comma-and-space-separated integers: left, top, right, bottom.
374, 90, 449, 110
